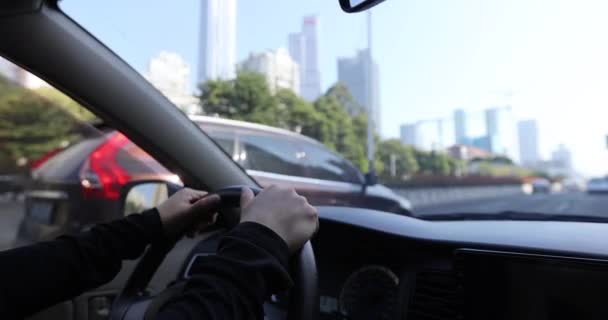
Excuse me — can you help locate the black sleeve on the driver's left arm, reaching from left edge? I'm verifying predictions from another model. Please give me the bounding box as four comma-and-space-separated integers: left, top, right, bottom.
0, 209, 164, 319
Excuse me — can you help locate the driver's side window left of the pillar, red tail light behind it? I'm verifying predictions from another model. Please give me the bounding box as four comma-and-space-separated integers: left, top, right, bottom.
0, 58, 179, 250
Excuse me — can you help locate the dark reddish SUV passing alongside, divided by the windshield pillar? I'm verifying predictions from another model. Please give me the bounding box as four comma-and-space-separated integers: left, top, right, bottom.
19, 116, 412, 242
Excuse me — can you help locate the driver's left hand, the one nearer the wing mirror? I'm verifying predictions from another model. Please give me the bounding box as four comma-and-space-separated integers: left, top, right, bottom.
156, 188, 220, 238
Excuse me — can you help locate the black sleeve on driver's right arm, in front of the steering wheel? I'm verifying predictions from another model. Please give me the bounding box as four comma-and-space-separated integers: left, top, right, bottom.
158, 222, 292, 320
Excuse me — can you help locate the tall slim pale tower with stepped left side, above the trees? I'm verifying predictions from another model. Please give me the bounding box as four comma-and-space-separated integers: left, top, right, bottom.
288, 16, 321, 101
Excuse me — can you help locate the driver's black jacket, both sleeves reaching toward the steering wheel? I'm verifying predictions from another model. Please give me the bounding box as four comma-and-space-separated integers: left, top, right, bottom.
0, 209, 291, 319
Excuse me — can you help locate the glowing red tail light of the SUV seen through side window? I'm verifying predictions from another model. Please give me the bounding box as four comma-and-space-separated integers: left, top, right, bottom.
80, 132, 131, 200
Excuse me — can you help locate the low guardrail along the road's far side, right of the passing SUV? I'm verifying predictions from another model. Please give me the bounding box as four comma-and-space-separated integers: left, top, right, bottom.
393, 184, 526, 208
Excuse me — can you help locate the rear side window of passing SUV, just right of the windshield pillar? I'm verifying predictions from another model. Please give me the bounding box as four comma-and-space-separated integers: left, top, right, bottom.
239, 133, 306, 177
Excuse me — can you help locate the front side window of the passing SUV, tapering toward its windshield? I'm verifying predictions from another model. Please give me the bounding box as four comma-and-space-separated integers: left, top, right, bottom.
302, 143, 362, 184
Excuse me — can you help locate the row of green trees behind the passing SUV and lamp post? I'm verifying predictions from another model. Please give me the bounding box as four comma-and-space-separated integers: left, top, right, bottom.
200, 72, 476, 179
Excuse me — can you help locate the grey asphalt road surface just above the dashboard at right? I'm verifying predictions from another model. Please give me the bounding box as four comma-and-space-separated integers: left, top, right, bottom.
414, 192, 608, 217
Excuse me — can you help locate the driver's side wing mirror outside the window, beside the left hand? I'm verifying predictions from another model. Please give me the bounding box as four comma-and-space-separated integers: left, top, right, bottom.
120, 181, 181, 215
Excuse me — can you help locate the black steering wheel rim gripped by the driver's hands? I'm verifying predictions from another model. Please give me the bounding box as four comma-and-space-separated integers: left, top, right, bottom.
110, 186, 319, 320
